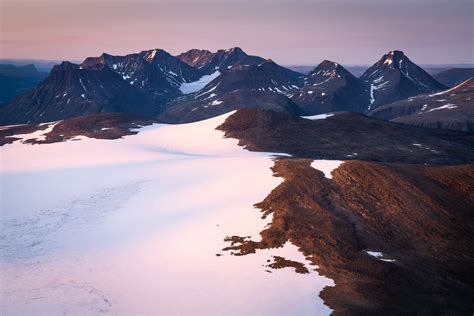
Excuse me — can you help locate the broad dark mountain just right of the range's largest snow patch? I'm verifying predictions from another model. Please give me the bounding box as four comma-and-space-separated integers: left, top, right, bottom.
159, 60, 303, 123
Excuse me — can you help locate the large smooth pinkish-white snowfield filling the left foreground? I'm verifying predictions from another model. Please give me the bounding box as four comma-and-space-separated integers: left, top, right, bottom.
0, 114, 335, 315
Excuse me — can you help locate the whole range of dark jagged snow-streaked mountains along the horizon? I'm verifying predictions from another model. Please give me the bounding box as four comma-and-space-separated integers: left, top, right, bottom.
0, 47, 471, 129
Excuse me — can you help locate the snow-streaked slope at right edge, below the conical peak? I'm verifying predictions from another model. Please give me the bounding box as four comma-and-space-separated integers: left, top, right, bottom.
370, 78, 474, 132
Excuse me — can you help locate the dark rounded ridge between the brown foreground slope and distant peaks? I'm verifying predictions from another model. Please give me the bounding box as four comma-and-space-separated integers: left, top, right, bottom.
218, 109, 474, 164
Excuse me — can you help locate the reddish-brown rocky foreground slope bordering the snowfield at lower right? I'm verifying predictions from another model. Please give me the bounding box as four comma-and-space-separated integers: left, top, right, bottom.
225, 158, 474, 315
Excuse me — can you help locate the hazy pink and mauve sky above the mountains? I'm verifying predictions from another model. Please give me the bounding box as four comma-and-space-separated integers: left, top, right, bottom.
0, 0, 474, 65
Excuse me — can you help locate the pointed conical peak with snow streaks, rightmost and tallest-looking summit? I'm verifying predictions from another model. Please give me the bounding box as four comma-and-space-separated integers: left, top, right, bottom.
360, 51, 446, 110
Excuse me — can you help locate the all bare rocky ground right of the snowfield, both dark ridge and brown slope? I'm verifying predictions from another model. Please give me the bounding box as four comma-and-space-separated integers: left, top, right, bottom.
219, 110, 474, 315
